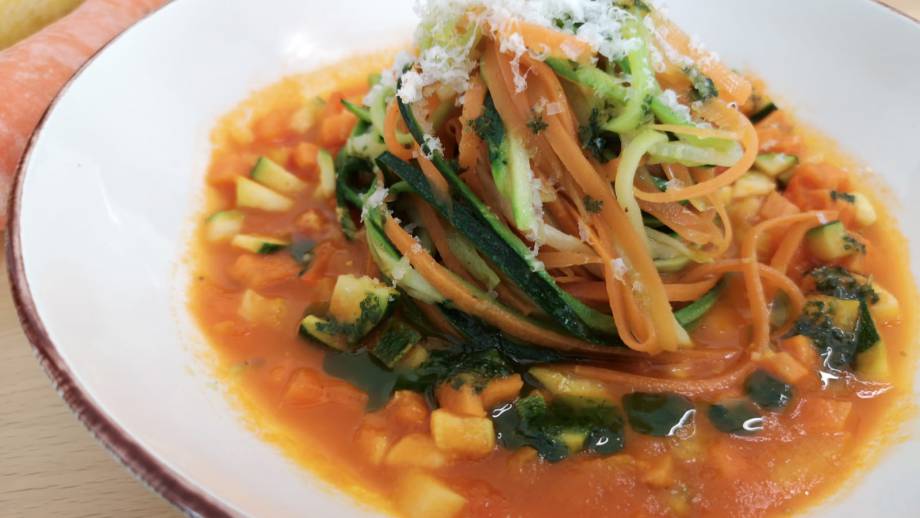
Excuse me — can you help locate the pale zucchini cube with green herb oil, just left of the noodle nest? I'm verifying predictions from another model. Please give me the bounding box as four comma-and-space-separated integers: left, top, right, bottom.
329, 274, 397, 324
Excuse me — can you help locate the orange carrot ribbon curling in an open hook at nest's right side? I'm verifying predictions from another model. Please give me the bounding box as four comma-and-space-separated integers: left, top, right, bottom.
636, 99, 758, 203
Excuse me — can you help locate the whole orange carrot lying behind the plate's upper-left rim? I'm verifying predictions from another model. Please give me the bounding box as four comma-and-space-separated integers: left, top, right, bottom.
0, 0, 168, 226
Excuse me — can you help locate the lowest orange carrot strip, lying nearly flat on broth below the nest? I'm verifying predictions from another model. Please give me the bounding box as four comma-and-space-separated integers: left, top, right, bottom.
563, 357, 754, 396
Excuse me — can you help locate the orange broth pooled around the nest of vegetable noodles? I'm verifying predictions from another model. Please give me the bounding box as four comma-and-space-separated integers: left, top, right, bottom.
189, 56, 916, 517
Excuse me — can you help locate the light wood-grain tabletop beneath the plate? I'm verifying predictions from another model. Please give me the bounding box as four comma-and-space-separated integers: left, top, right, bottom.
0, 0, 920, 518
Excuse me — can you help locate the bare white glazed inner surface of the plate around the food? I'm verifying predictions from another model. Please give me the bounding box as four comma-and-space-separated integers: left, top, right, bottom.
11, 0, 920, 517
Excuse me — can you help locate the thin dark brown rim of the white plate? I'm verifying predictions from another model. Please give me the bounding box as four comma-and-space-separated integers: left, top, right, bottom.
5, 0, 920, 517
